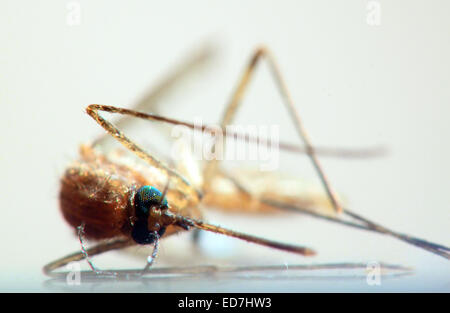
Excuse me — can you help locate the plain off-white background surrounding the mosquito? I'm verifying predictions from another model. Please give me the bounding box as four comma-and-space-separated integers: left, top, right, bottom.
0, 0, 450, 291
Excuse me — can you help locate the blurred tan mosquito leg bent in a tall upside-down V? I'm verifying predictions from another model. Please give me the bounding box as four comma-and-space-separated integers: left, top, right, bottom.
204, 48, 342, 212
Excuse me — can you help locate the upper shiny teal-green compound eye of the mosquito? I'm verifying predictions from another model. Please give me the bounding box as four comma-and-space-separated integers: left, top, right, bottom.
134, 186, 168, 219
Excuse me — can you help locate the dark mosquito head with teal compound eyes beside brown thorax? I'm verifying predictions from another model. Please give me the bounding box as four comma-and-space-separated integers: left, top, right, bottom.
131, 186, 170, 244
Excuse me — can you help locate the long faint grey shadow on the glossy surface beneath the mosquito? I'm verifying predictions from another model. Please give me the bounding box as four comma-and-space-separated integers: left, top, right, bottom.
43, 263, 414, 292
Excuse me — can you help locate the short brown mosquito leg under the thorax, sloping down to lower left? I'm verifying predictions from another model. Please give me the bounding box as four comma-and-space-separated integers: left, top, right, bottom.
43, 238, 136, 276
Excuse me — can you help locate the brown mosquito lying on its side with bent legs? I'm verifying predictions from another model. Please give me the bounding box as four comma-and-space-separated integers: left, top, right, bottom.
44, 47, 450, 275
